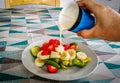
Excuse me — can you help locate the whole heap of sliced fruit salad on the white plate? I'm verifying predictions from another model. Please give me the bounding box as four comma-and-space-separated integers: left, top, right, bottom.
30, 39, 91, 73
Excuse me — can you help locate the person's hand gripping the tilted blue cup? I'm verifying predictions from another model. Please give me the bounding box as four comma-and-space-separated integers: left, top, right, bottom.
77, 0, 120, 41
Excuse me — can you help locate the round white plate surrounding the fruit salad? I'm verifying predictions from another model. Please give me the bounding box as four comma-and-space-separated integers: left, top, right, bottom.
22, 38, 98, 81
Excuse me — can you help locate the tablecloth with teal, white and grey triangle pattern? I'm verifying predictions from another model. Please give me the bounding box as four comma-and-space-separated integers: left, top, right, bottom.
0, 8, 120, 83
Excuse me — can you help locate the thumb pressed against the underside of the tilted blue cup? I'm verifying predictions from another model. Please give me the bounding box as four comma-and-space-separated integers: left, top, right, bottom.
77, 27, 95, 38
